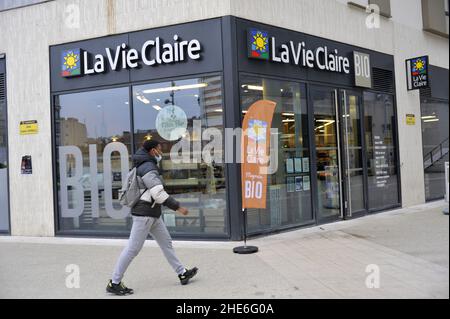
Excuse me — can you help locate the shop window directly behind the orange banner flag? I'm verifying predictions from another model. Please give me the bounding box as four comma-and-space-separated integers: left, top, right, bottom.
240, 76, 313, 232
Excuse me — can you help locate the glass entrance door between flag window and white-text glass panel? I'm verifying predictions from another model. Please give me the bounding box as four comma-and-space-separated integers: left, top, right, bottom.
311, 87, 366, 221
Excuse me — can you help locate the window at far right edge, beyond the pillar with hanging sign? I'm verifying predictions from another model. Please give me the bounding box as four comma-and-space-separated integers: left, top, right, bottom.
420, 98, 449, 200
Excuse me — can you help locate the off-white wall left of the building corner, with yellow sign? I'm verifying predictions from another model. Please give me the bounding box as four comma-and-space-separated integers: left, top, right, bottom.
0, 0, 229, 236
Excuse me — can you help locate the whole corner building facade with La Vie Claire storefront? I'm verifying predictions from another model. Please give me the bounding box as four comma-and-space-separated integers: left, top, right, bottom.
0, 0, 448, 240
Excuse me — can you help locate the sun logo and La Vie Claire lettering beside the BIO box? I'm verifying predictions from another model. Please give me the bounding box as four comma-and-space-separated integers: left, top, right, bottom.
247, 29, 350, 74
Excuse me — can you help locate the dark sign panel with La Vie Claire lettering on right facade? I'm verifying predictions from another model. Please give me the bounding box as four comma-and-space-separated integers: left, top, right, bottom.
237, 19, 394, 86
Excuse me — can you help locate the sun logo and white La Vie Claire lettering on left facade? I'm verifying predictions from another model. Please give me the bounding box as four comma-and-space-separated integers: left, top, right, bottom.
61, 34, 202, 77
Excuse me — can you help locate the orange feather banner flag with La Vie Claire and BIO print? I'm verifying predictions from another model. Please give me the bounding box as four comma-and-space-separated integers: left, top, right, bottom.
241, 100, 277, 209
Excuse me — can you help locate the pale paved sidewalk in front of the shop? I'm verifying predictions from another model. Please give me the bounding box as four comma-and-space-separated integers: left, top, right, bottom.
0, 201, 449, 299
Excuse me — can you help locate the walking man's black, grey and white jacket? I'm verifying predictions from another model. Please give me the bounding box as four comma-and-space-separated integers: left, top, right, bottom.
131, 148, 180, 218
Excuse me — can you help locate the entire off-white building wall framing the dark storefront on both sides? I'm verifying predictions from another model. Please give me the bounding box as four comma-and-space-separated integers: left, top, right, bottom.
0, 0, 448, 236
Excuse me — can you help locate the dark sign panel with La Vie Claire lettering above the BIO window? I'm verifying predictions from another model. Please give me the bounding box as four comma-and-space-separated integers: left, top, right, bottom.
50, 19, 223, 92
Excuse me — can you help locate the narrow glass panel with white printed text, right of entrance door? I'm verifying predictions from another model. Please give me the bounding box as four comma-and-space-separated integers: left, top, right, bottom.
364, 92, 399, 210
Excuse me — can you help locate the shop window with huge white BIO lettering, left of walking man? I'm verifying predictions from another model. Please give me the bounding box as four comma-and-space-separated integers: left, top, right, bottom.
54, 88, 131, 233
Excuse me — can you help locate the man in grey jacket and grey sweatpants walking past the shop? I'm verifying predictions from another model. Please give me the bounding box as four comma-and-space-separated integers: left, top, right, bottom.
106, 141, 198, 296
